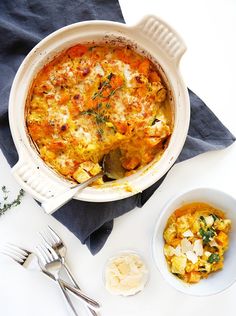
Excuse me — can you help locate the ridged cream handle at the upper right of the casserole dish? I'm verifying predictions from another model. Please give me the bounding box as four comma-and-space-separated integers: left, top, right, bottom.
134, 15, 187, 67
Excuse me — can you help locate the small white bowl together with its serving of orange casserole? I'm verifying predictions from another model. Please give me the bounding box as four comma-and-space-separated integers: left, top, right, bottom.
152, 188, 236, 296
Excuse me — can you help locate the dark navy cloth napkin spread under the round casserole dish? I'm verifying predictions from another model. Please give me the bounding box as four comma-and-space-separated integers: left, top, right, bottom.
0, 0, 235, 254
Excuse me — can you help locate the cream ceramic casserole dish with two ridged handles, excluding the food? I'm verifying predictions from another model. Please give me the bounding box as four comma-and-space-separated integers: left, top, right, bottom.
9, 16, 190, 209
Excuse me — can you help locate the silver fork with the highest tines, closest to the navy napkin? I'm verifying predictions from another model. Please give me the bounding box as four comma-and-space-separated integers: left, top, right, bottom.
40, 226, 98, 316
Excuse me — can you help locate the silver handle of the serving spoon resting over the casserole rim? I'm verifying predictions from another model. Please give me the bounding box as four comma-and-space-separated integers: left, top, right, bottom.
41, 172, 103, 214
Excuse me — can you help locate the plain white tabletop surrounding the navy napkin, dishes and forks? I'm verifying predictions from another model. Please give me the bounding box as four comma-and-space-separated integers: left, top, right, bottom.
0, 0, 236, 316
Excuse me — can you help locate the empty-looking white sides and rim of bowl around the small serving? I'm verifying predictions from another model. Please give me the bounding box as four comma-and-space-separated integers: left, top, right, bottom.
152, 188, 236, 296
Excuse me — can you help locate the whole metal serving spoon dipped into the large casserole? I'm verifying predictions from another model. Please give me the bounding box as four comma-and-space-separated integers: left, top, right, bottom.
41, 149, 125, 214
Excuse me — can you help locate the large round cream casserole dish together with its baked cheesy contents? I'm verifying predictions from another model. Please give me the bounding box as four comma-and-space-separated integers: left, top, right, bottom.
9, 16, 190, 207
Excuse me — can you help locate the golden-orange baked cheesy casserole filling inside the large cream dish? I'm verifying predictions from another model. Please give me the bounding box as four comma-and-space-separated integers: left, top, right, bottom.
26, 44, 172, 182
